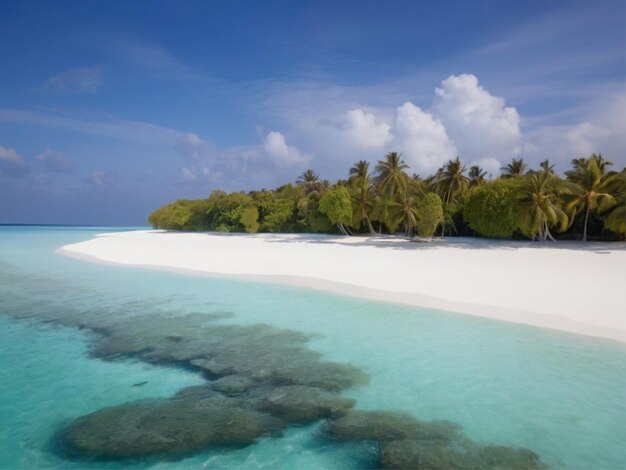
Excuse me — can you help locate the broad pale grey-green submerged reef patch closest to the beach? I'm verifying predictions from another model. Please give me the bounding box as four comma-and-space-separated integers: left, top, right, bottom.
86, 315, 368, 391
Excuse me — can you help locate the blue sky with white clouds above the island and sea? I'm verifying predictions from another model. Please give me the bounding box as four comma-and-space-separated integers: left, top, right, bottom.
0, 0, 626, 225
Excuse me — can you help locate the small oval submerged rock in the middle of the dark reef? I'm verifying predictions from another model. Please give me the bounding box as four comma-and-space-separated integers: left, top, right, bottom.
261, 385, 356, 422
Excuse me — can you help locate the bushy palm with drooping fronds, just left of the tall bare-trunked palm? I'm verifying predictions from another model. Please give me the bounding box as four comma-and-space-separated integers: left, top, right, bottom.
514, 173, 570, 241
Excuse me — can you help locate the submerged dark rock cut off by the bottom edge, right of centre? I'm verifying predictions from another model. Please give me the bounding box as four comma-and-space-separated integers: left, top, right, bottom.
381, 439, 546, 470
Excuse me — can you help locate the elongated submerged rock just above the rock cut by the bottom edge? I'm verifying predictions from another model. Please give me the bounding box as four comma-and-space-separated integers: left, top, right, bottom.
326, 410, 461, 442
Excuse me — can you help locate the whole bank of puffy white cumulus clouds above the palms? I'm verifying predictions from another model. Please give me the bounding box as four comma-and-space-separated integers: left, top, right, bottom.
268, 74, 523, 177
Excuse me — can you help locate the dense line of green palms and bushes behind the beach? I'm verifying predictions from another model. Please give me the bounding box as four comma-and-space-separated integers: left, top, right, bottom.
148, 152, 626, 240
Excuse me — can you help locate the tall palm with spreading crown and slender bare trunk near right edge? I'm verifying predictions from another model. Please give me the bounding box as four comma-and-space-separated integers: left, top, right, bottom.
565, 154, 620, 241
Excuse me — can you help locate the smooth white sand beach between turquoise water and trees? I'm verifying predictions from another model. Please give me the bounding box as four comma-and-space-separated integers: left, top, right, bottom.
58, 231, 626, 342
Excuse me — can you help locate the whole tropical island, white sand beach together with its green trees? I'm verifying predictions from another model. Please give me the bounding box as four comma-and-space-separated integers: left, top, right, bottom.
59, 153, 626, 341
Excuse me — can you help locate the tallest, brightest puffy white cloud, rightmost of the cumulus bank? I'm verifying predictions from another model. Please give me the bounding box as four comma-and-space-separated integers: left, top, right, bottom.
432, 74, 522, 160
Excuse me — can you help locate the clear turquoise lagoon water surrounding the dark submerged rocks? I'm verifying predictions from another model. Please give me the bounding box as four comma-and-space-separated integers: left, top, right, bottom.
0, 227, 626, 469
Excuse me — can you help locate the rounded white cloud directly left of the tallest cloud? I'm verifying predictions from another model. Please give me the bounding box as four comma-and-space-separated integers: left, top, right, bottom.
391, 102, 456, 174
